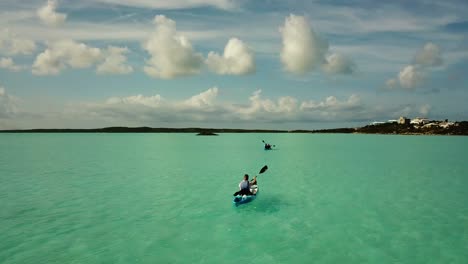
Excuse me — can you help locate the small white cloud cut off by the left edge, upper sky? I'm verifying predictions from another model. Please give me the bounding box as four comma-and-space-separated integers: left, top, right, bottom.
0, 29, 36, 55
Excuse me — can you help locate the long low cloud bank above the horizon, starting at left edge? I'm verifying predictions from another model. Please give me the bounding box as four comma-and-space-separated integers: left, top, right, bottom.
0, 87, 431, 128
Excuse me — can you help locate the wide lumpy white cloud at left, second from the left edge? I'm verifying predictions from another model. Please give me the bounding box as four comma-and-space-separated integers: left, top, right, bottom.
32, 40, 103, 75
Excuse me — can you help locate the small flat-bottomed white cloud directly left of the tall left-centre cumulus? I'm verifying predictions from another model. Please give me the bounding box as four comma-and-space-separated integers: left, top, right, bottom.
96, 46, 133, 74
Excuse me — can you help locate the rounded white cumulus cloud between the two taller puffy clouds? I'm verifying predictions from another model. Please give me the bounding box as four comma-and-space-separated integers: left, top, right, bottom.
206, 38, 255, 75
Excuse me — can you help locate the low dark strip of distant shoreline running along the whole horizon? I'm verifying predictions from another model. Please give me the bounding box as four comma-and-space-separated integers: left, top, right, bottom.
0, 121, 468, 135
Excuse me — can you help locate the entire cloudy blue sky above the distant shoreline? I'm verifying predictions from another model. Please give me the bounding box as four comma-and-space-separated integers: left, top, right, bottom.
0, 0, 468, 129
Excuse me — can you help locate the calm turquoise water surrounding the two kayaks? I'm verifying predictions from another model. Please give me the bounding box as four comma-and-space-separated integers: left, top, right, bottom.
0, 134, 468, 264
